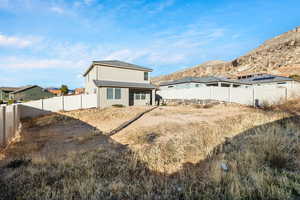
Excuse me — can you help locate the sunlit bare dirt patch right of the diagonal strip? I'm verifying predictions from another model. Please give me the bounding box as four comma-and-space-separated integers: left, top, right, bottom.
113, 104, 253, 144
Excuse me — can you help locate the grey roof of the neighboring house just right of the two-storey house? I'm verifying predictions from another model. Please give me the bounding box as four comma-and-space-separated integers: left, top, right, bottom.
160, 76, 246, 86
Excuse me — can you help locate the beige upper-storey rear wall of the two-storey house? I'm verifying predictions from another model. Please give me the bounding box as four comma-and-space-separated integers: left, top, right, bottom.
98, 66, 150, 83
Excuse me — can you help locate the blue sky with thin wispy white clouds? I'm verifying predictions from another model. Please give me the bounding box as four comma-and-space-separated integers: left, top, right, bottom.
0, 0, 300, 88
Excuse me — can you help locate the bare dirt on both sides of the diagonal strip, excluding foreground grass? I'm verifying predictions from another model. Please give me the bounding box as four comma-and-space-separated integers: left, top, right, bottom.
2, 105, 255, 164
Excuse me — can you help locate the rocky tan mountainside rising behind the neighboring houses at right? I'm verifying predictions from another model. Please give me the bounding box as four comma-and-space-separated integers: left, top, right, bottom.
152, 27, 300, 84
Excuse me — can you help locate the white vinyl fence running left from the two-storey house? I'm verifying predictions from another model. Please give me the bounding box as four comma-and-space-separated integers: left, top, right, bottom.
21, 94, 98, 118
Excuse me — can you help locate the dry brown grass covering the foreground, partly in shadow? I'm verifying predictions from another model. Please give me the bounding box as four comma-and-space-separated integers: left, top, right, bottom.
0, 101, 300, 200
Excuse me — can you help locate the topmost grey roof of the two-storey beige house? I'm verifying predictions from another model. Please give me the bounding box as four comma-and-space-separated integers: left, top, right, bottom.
83, 60, 153, 76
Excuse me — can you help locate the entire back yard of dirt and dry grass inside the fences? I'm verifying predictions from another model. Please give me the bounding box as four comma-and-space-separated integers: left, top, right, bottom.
0, 101, 300, 199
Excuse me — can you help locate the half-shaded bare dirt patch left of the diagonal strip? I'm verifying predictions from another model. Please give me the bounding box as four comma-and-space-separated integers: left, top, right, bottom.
0, 106, 151, 161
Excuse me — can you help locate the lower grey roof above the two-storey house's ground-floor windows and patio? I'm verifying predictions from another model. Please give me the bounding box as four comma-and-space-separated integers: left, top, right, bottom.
94, 80, 156, 89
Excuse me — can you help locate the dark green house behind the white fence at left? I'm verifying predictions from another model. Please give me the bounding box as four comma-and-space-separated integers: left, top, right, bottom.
11, 87, 54, 101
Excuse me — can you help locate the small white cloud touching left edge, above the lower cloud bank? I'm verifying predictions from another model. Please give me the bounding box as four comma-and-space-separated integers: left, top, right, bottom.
0, 33, 37, 48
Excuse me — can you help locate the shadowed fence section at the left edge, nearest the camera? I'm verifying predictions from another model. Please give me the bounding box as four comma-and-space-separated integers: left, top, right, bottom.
0, 105, 21, 149
